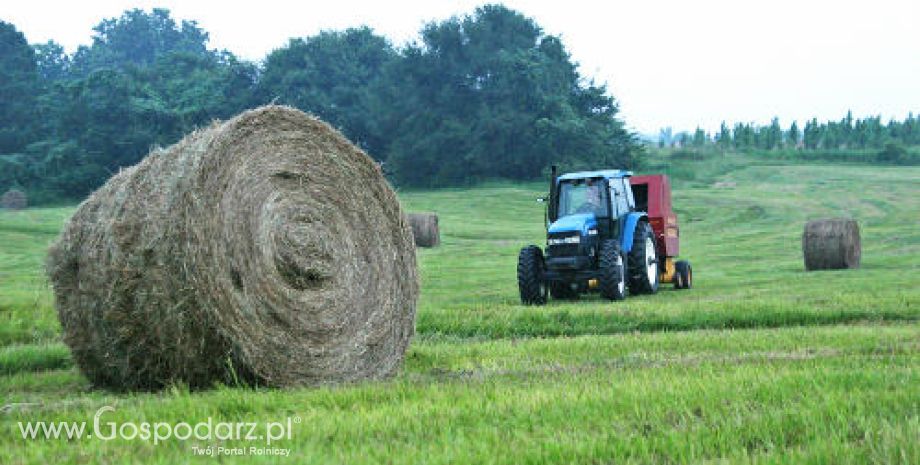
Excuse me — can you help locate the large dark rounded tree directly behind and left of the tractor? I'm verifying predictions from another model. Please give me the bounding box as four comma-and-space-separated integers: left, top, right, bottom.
379, 5, 636, 185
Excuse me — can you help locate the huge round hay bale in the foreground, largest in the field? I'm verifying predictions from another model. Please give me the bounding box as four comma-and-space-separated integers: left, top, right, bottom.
48, 106, 419, 389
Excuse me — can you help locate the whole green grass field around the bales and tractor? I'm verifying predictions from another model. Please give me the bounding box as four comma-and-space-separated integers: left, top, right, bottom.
0, 154, 920, 464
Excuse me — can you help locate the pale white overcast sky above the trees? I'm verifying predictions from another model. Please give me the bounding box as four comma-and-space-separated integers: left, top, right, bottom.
0, 0, 920, 133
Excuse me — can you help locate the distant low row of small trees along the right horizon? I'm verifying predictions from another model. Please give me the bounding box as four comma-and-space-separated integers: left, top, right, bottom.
658, 112, 920, 154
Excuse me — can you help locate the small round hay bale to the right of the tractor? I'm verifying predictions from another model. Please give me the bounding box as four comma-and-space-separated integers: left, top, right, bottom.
802, 218, 862, 271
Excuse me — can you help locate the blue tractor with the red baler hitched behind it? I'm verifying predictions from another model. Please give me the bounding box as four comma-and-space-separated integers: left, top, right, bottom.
517, 166, 692, 305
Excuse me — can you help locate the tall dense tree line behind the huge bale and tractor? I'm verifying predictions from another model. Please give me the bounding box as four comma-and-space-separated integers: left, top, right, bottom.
0, 5, 641, 200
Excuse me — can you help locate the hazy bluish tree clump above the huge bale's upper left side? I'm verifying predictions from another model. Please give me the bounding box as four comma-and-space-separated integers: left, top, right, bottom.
10, 10, 258, 196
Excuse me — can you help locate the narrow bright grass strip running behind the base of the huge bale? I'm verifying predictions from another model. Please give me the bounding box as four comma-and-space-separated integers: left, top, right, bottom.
0, 323, 920, 382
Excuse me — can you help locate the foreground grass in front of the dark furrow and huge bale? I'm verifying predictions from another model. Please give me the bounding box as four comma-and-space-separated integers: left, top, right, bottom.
0, 325, 920, 463
